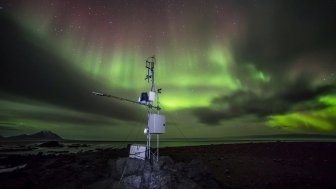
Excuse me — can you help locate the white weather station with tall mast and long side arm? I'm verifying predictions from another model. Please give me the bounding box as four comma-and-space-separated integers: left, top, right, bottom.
92, 56, 166, 161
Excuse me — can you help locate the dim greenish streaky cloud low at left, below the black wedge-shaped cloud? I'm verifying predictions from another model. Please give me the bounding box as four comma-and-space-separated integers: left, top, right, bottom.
0, 96, 135, 127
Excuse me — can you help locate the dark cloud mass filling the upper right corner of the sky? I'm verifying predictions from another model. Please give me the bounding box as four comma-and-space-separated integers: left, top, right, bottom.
234, 1, 336, 74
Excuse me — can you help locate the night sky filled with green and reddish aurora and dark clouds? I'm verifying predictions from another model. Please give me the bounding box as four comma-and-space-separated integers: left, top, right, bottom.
0, 0, 336, 140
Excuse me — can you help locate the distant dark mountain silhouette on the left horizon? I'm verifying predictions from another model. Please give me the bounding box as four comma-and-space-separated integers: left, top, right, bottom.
2, 131, 63, 140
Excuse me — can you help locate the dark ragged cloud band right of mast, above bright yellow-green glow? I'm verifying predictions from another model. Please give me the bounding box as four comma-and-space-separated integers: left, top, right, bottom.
193, 81, 336, 125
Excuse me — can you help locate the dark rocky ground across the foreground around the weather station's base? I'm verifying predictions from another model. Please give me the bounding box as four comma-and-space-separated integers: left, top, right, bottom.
0, 142, 336, 189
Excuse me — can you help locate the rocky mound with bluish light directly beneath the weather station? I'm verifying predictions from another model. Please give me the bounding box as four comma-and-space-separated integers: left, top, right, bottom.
101, 157, 221, 189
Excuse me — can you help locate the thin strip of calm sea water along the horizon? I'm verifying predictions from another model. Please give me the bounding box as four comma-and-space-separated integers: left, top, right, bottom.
0, 138, 336, 154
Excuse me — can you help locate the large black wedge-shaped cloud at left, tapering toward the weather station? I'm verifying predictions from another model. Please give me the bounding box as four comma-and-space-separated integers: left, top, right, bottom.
0, 17, 141, 123
